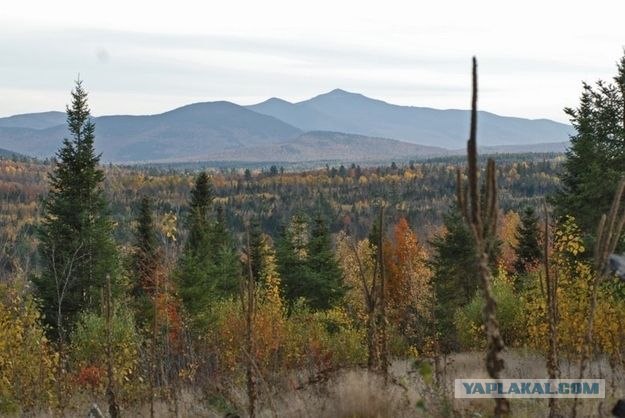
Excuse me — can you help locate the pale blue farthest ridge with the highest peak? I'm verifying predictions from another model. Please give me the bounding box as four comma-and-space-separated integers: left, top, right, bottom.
249, 89, 572, 149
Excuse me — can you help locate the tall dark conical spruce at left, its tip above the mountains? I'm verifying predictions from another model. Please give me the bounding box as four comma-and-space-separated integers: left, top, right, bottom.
34, 81, 119, 341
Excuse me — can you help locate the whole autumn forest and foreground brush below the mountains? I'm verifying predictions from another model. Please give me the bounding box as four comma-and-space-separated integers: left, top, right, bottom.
0, 57, 625, 417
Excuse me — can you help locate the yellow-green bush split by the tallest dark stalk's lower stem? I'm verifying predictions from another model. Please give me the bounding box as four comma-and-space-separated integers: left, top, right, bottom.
454, 271, 526, 350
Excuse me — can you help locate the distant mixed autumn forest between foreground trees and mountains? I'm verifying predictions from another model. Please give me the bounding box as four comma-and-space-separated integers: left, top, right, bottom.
0, 154, 563, 276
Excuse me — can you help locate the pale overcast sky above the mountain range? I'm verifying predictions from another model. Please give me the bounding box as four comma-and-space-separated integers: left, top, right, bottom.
0, 0, 625, 122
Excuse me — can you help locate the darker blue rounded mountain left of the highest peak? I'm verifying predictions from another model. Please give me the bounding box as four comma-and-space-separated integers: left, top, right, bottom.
0, 102, 301, 162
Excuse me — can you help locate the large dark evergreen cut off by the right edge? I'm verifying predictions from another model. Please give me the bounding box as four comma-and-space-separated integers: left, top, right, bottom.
552, 52, 625, 237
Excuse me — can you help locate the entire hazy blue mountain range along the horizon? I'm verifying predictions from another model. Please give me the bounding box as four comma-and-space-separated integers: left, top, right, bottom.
0, 89, 573, 162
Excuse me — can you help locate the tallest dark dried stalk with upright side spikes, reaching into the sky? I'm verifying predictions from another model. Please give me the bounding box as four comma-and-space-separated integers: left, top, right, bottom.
457, 57, 510, 417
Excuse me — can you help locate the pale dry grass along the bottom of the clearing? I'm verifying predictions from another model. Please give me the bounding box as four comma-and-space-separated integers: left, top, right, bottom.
20, 351, 625, 418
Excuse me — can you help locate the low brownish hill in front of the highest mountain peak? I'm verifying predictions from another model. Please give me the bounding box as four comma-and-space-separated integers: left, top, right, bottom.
206, 131, 449, 162
